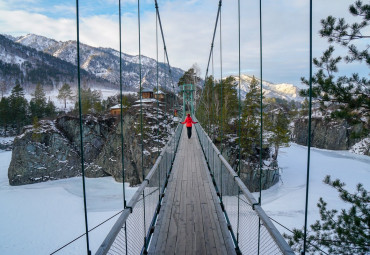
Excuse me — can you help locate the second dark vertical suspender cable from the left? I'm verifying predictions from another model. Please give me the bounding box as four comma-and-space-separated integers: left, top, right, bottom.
119, 0, 126, 208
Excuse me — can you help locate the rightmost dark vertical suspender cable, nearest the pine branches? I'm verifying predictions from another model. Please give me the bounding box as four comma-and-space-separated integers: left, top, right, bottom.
303, 0, 312, 254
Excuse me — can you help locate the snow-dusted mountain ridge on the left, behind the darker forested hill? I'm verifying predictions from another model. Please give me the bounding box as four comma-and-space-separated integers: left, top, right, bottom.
15, 34, 184, 90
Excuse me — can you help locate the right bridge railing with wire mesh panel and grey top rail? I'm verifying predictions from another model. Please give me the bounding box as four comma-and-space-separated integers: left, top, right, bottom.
195, 122, 294, 255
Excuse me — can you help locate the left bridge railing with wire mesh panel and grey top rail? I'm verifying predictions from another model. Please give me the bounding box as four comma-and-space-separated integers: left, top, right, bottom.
96, 124, 182, 255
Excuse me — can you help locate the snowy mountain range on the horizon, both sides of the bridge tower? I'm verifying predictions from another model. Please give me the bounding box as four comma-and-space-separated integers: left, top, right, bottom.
0, 34, 302, 101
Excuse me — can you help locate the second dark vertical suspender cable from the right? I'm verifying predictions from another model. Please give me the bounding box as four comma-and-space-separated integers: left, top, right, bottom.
258, 0, 263, 254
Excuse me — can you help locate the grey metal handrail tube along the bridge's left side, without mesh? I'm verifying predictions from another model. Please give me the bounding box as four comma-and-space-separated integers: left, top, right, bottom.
96, 124, 182, 255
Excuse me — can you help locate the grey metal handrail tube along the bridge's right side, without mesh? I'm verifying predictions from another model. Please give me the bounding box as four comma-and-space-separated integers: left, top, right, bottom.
196, 121, 294, 255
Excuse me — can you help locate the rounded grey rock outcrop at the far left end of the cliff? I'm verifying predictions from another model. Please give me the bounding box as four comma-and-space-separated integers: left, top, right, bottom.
8, 121, 81, 185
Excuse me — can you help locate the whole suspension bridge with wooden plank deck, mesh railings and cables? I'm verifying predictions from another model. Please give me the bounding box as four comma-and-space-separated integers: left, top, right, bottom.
49, 0, 320, 255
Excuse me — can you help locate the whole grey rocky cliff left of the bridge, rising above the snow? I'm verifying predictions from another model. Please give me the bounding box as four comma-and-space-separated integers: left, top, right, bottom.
8, 106, 174, 185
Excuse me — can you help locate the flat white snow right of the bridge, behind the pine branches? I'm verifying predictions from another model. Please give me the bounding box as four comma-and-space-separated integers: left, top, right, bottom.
260, 144, 370, 232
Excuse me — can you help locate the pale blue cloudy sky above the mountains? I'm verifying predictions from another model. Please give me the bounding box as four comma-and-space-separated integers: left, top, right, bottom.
0, 0, 369, 87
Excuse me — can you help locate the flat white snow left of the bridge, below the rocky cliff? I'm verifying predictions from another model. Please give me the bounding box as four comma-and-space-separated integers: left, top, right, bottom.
0, 150, 137, 254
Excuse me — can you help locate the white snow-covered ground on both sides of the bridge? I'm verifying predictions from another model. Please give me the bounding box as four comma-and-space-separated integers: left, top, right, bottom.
0, 144, 370, 255
